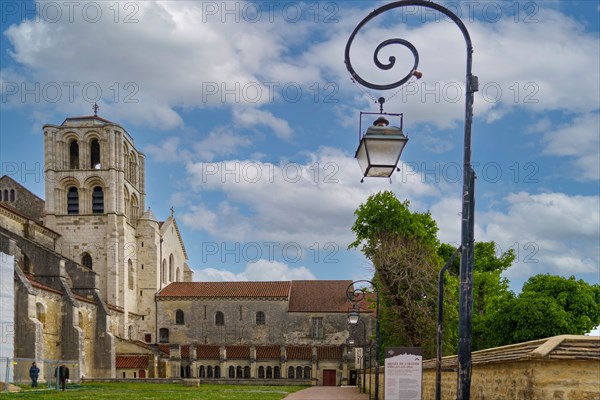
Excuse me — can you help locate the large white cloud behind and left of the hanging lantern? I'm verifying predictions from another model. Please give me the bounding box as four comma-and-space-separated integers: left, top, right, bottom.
183, 148, 438, 248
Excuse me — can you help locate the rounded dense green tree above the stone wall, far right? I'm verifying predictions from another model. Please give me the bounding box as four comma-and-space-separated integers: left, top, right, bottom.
487, 274, 600, 345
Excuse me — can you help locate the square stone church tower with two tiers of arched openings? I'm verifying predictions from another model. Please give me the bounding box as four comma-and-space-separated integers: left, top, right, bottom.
44, 109, 146, 334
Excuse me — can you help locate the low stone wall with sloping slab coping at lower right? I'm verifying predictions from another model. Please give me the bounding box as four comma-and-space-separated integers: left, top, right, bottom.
360, 335, 600, 400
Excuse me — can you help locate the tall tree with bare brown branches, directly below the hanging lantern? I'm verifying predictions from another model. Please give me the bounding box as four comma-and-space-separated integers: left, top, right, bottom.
349, 191, 439, 356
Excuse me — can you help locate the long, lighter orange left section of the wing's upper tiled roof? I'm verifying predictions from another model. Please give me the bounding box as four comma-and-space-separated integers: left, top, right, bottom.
157, 282, 291, 298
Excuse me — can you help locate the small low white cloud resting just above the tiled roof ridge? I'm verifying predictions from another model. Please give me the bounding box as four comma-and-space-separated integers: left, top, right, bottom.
194, 259, 316, 282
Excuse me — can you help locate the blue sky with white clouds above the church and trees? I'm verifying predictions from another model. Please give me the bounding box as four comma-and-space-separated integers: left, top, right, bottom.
0, 1, 600, 291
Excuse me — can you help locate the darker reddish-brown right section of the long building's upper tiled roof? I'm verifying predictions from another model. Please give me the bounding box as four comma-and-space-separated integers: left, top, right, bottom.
288, 280, 352, 313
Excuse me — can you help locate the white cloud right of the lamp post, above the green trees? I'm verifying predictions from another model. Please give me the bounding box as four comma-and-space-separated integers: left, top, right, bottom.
476, 192, 600, 277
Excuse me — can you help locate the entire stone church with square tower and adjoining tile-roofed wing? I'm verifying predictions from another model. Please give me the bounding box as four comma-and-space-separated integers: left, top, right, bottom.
0, 115, 371, 384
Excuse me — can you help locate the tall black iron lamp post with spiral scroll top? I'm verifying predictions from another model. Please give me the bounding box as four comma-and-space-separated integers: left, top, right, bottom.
344, 0, 478, 400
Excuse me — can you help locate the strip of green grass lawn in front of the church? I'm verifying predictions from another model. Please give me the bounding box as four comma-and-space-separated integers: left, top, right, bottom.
0, 383, 306, 400
